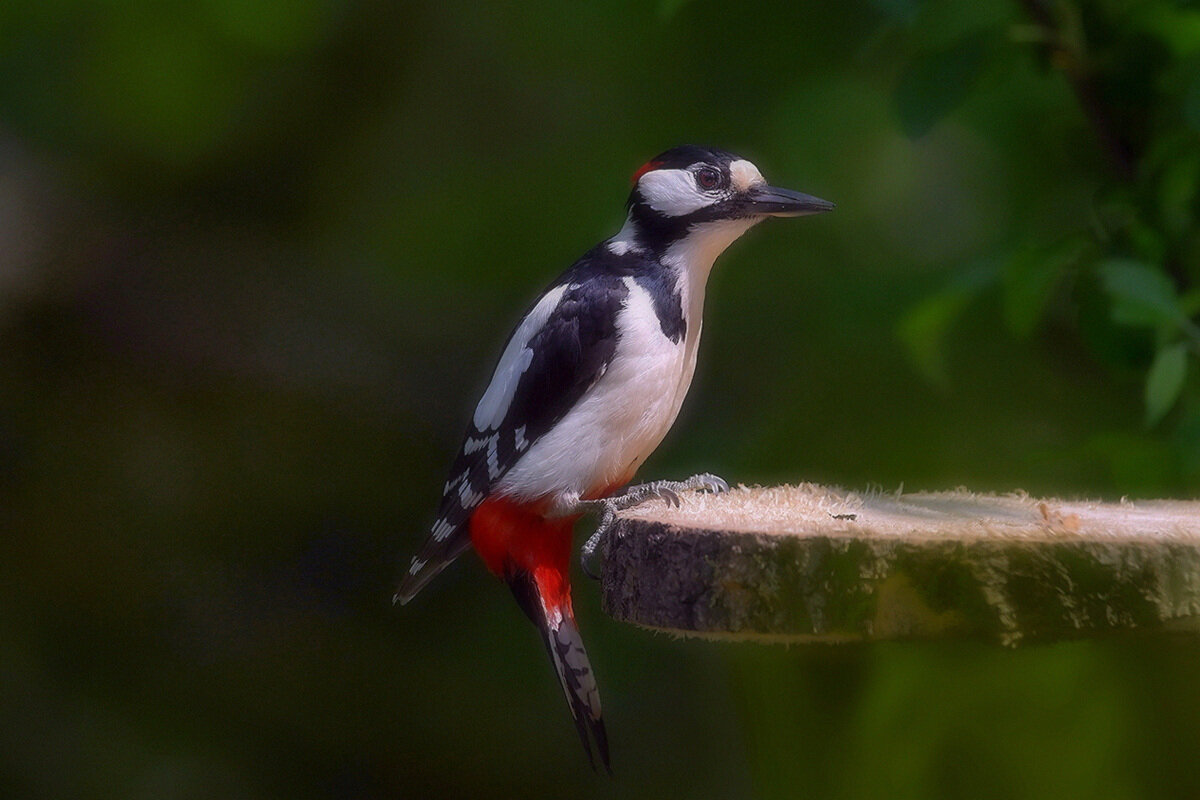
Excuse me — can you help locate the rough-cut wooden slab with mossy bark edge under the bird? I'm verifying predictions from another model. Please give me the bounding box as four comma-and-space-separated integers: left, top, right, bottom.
601, 483, 1200, 645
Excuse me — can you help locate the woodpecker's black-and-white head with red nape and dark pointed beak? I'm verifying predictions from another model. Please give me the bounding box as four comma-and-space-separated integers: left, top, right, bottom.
629, 145, 834, 256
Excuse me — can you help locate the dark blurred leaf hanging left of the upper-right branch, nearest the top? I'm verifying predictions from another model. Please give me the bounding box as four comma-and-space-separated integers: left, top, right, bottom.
895, 31, 994, 139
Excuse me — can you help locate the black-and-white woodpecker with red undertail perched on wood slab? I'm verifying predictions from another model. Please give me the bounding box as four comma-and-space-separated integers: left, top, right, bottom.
396, 145, 834, 771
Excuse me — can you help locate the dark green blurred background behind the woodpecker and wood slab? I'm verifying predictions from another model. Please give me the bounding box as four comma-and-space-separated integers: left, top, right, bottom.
0, 0, 1200, 799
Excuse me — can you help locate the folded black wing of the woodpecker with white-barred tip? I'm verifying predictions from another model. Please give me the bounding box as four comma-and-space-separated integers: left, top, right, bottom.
395, 260, 629, 603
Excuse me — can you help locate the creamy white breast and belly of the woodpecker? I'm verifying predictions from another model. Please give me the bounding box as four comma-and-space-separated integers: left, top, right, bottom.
497, 278, 700, 499
